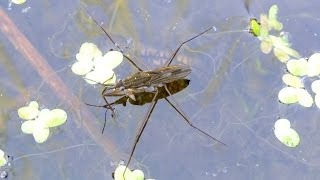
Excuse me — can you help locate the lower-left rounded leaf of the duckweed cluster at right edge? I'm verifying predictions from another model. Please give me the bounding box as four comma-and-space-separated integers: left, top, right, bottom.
278, 87, 298, 104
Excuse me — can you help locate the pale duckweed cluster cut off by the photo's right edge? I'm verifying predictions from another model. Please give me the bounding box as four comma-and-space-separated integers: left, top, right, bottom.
278, 53, 320, 108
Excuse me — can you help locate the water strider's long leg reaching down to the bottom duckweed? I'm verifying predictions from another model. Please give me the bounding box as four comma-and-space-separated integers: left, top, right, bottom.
123, 90, 158, 175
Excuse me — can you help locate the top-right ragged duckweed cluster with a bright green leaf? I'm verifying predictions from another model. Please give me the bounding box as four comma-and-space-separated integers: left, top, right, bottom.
250, 5, 300, 62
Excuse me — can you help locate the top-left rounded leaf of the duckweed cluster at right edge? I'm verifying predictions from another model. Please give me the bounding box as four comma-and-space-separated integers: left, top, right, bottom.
287, 58, 308, 76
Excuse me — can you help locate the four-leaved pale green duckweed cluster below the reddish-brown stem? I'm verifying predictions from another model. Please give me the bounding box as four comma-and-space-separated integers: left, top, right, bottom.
18, 101, 67, 143
